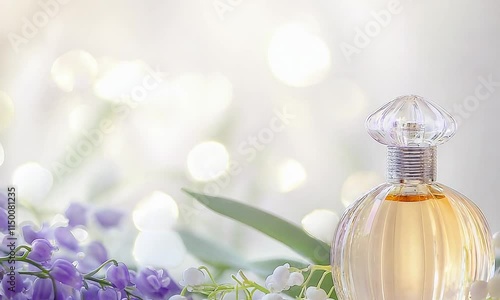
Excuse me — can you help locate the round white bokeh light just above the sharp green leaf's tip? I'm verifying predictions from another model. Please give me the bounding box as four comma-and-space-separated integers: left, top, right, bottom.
187, 141, 229, 181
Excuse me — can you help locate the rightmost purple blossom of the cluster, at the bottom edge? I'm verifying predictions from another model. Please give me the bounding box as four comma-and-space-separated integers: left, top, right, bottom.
135, 268, 180, 299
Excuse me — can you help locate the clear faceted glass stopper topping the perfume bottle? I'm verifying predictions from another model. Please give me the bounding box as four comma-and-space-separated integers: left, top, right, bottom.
366, 95, 457, 147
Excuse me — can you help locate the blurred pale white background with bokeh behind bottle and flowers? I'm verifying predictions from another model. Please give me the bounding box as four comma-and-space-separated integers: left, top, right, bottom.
0, 0, 500, 275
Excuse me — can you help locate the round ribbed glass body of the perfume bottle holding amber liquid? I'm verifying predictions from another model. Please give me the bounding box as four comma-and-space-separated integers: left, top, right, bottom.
331, 183, 495, 300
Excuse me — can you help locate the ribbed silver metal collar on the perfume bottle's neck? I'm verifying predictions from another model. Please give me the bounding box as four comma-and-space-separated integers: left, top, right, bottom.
387, 146, 437, 183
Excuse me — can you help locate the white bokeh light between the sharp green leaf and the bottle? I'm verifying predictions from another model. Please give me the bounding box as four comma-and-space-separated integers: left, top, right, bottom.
302, 209, 339, 244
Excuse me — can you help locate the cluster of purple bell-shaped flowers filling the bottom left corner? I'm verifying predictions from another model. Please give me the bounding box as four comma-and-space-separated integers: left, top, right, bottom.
0, 197, 180, 300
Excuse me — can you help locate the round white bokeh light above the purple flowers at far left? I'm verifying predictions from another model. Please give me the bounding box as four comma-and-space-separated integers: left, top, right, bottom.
12, 162, 53, 203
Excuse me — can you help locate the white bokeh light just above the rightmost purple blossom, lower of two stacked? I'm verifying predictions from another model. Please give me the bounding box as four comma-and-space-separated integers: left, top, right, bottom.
133, 231, 186, 268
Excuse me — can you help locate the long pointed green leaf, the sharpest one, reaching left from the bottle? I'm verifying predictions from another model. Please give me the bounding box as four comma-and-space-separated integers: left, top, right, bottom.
183, 189, 330, 265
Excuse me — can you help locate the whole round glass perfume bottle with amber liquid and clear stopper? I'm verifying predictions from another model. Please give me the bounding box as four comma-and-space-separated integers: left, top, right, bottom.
331, 96, 495, 300
